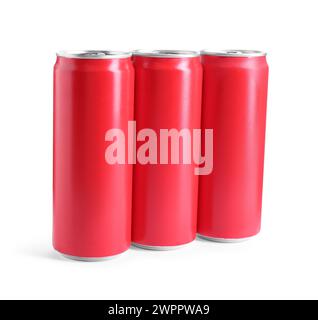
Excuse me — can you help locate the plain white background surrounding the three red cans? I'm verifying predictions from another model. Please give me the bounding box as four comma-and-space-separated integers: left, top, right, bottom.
0, 0, 318, 299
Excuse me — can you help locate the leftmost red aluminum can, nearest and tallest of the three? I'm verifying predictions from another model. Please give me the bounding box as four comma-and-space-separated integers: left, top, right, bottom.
53, 51, 134, 260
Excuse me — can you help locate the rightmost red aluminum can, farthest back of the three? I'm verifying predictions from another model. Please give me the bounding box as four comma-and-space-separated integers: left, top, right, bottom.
198, 50, 268, 242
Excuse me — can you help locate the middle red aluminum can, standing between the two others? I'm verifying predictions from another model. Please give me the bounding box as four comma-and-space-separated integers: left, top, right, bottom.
132, 50, 202, 250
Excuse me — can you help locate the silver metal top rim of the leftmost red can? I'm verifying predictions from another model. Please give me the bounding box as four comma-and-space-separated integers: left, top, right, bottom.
56, 50, 131, 59
